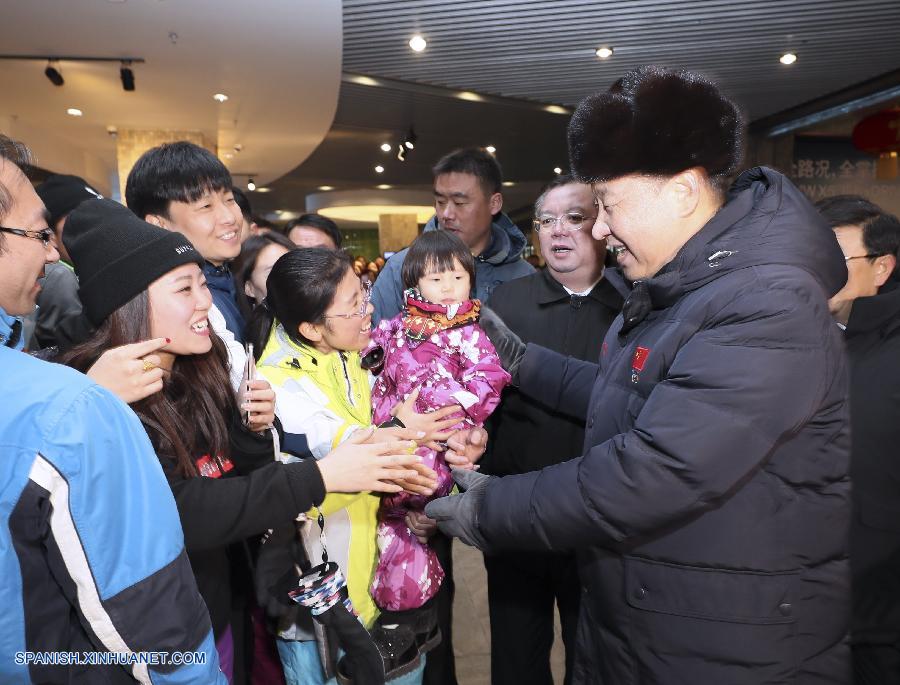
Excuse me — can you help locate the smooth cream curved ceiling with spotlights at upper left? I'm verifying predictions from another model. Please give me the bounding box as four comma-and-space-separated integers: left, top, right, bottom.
0, 0, 342, 192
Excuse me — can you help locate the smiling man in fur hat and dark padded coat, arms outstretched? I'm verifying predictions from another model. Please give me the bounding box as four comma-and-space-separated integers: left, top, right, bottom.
426, 67, 851, 685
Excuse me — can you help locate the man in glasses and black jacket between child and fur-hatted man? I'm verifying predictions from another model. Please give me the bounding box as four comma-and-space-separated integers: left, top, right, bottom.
480, 176, 622, 685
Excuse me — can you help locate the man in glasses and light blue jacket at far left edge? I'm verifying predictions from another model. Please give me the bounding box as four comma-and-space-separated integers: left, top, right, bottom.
0, 135, 226, 685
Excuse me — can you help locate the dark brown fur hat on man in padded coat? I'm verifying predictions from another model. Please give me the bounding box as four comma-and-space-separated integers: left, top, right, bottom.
569, 67, 743, 183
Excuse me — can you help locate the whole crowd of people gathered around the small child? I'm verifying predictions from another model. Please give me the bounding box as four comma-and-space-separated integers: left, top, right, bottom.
0, 68, 900, 685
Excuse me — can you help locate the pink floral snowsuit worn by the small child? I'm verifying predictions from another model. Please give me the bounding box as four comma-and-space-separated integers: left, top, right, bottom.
363, 291, 510, 611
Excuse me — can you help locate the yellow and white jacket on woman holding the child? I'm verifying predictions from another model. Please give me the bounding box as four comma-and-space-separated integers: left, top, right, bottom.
257, 323, 379, 627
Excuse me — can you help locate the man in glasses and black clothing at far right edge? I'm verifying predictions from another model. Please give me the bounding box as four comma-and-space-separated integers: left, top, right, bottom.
816, 195, 900, 685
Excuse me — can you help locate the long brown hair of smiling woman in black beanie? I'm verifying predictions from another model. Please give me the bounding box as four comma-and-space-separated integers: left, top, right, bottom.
60, 290, 238, 478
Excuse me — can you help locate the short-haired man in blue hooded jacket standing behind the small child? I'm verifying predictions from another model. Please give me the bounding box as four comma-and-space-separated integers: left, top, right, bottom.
372, 148, 534, 325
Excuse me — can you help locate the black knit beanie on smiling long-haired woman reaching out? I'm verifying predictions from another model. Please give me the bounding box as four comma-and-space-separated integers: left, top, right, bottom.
63, 200, 203, 326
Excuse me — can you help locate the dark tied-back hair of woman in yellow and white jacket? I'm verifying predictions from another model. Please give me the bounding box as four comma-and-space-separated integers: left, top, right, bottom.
245, 247, 353, 360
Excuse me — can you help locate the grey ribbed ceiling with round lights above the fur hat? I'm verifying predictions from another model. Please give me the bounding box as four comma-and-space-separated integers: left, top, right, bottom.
344, 0, 900, 118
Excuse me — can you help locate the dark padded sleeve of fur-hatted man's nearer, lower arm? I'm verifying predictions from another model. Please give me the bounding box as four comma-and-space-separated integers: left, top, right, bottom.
479, 280, 846, 550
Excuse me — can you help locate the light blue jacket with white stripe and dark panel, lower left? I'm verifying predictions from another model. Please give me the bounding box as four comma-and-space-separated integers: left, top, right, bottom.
0, 353, 226, 685
